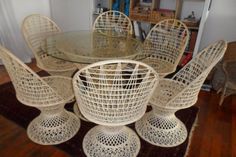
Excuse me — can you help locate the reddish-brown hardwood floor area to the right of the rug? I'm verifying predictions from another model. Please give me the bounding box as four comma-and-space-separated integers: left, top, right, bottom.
185, 92, 236, 157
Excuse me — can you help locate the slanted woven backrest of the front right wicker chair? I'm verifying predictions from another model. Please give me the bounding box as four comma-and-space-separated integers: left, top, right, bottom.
152, 40, 227, 109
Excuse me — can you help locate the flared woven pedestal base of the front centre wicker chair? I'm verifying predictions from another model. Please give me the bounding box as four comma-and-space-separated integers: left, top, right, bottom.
83, 125, 140, 157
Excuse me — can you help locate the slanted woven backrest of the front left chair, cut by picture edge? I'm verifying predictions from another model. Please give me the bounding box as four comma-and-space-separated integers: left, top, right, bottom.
0, 47, 65, 107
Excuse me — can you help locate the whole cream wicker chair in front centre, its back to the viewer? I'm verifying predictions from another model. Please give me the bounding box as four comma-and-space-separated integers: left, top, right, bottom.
73, 60, 159, 157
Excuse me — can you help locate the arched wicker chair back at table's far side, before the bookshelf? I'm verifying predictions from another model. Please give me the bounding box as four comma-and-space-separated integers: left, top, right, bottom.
93, 10, 133, 37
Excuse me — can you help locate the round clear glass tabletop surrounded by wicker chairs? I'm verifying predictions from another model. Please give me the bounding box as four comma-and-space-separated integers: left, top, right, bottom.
46, 31, 143, 63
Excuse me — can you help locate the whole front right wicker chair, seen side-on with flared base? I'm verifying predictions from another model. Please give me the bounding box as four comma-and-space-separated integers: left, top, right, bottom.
135, 41, 227, 147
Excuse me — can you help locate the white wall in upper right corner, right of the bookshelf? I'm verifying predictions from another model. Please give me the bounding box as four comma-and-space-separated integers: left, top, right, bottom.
200, 0, 236, 49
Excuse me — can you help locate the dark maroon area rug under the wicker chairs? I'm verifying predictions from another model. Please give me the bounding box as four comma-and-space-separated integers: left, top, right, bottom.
0, 73, 198, 157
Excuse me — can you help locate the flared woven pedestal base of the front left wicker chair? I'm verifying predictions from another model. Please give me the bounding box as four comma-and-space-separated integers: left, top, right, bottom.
27, 105, 80, 145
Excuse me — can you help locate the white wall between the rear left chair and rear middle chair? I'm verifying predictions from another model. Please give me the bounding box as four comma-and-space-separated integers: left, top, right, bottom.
50, 0, 93, 31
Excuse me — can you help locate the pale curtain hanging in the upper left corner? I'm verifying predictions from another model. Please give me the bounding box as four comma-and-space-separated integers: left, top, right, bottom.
0, 0, 32, 62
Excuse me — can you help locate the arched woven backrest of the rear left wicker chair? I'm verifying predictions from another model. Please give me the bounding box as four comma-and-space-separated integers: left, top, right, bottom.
22, 14, 61, 67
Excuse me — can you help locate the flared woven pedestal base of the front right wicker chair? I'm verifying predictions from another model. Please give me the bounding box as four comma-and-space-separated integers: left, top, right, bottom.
135, 111, 188, 147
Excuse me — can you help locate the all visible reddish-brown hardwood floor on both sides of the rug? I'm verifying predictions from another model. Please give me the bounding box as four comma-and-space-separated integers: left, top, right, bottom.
0, 59, 236, 157
